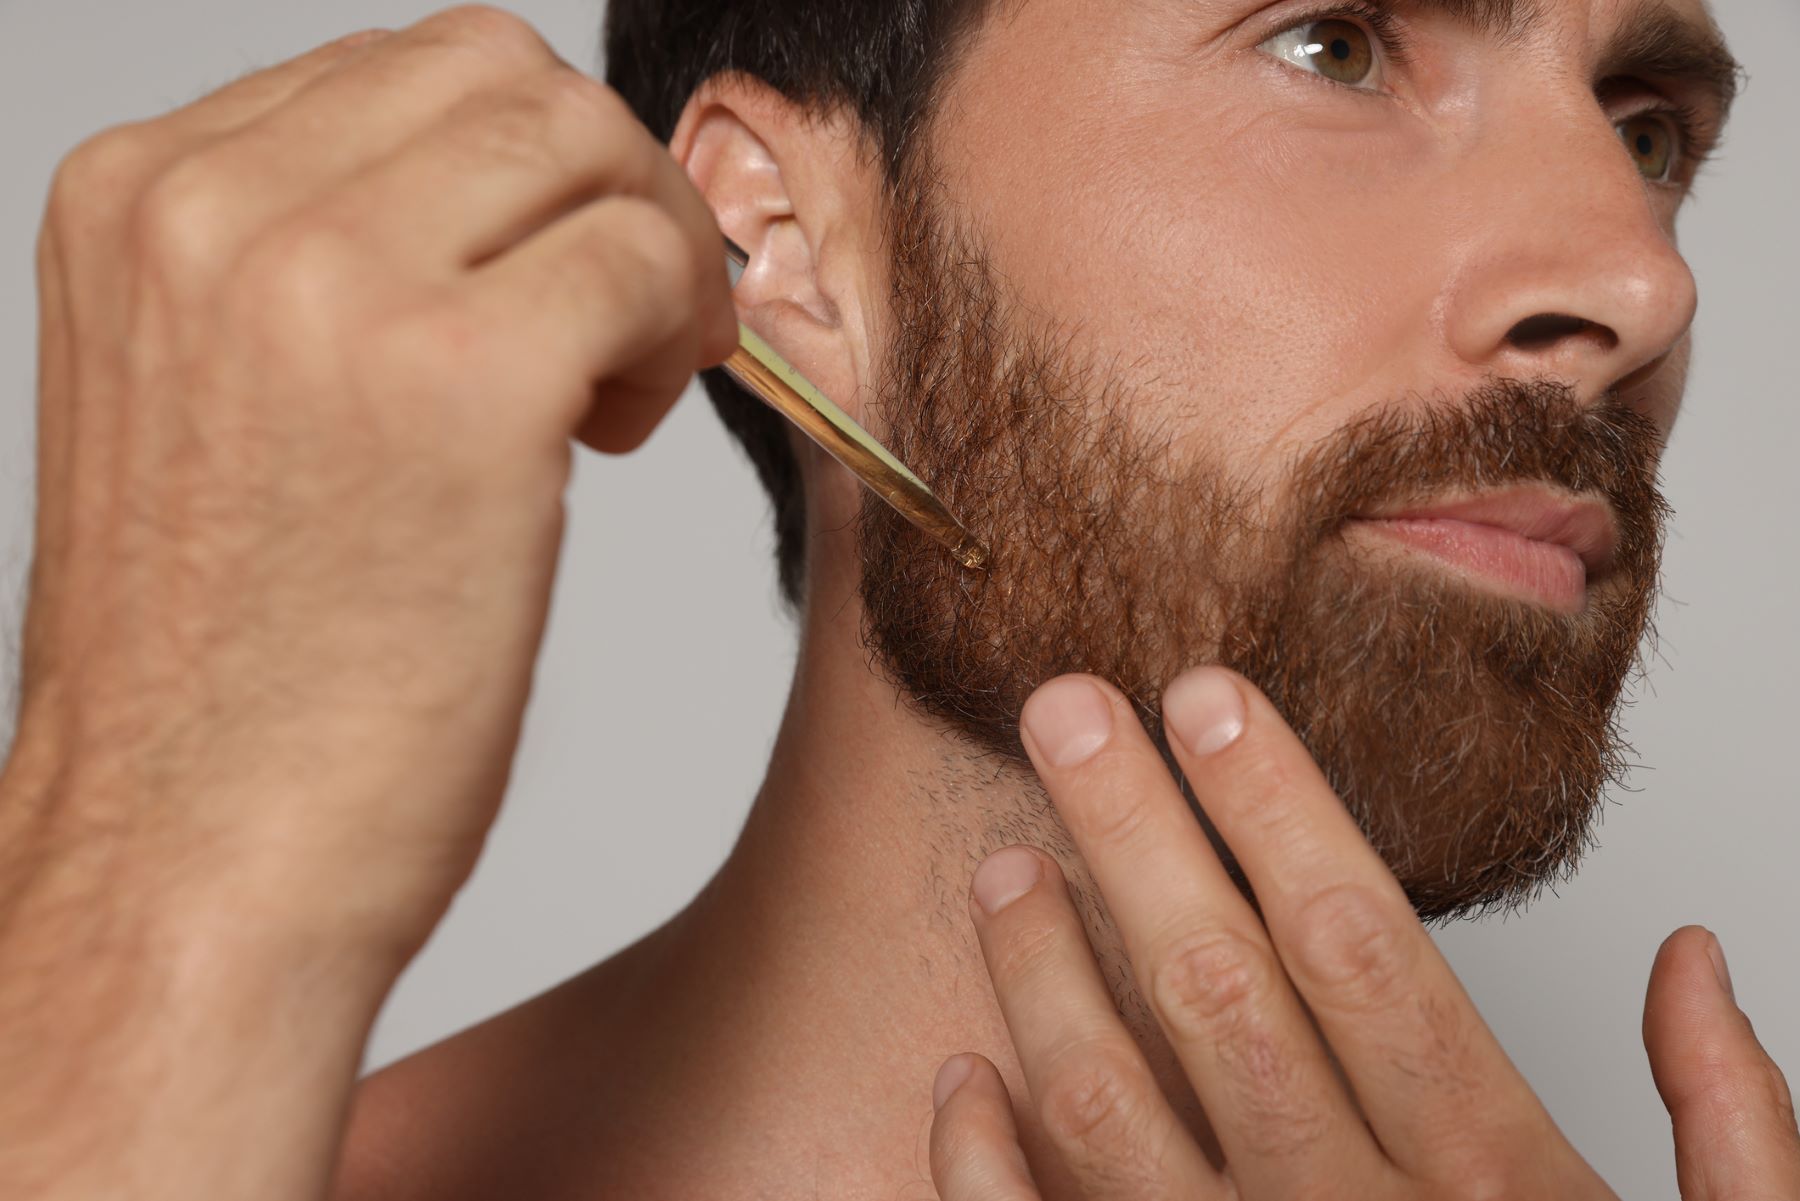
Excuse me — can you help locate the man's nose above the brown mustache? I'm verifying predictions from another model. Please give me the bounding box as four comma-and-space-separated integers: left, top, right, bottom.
1444, 95, 1697, 408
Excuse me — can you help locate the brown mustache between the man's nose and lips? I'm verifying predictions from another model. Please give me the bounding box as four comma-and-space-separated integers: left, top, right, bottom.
1291, 376, 1672, 571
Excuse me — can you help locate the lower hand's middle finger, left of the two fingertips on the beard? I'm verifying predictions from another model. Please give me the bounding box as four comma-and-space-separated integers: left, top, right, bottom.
1021, 675, 1381, 1197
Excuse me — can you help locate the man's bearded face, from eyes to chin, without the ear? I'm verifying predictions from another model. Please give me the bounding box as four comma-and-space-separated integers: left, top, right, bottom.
842, 0, 1726, 917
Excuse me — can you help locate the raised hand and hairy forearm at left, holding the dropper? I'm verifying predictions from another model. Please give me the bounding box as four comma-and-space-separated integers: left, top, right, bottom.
0, 7, 736, 1199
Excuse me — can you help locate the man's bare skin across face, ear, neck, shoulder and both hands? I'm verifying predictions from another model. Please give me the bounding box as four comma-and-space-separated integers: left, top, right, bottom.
0, 0, 1800, 1201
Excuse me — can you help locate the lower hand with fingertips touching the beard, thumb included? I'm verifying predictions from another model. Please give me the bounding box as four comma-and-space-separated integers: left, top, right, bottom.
931, 668, 1800, 1201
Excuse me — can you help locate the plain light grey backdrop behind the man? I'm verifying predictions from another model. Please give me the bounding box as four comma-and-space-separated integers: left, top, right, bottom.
0, 0, 1800, 1197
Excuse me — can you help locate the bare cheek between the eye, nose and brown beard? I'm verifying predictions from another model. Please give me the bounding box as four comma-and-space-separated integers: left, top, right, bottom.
963, 52, 1447, 474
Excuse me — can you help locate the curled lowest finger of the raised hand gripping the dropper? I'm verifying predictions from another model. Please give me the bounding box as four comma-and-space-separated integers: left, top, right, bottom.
459, 196, 716, 452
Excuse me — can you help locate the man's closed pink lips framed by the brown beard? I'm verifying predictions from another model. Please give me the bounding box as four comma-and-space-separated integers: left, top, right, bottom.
1348, 486, 1618, 612
